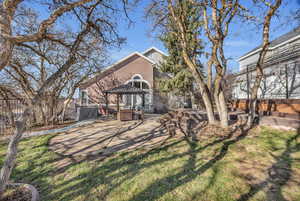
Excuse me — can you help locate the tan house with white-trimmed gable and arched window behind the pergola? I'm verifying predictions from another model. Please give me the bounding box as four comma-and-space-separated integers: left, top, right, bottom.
80, 47, 167, 112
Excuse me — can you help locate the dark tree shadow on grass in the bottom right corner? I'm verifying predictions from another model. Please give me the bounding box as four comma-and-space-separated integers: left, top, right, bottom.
237, 129, 300, 201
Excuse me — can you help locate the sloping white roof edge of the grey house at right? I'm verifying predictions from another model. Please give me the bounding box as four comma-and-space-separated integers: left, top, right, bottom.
238, 26, 300, 61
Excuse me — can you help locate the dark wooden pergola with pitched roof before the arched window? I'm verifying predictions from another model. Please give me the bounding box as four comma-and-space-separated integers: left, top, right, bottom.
104, 84, 147, 120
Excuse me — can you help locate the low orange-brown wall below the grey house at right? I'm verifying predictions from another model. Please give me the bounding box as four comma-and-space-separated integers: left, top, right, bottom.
231, 99, 300, 118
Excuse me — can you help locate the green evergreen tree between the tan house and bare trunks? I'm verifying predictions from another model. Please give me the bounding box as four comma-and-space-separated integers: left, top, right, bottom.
159, 1, 203, 98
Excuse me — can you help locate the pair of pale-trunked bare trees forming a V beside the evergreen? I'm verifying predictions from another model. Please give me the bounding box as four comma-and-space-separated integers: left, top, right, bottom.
150, 0, 243, 127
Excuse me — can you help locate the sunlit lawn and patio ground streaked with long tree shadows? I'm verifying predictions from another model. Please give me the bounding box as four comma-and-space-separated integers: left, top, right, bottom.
0, 116, 300, 201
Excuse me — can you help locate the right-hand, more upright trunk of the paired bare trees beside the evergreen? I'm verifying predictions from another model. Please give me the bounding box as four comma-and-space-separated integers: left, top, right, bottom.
200, 0, 242, 127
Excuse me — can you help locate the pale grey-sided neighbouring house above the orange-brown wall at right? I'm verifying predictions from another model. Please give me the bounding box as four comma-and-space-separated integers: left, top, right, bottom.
233, 27, 300, 99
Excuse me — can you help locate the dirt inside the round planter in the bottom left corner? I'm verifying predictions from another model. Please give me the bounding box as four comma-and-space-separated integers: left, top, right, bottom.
1, 186, 31, 201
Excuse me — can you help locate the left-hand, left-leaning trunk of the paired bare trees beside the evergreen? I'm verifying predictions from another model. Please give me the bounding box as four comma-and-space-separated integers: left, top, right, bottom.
147, 0, 216, 124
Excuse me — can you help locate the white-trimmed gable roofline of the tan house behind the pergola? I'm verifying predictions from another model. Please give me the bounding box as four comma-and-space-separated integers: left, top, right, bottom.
80, 47, 164, 88
